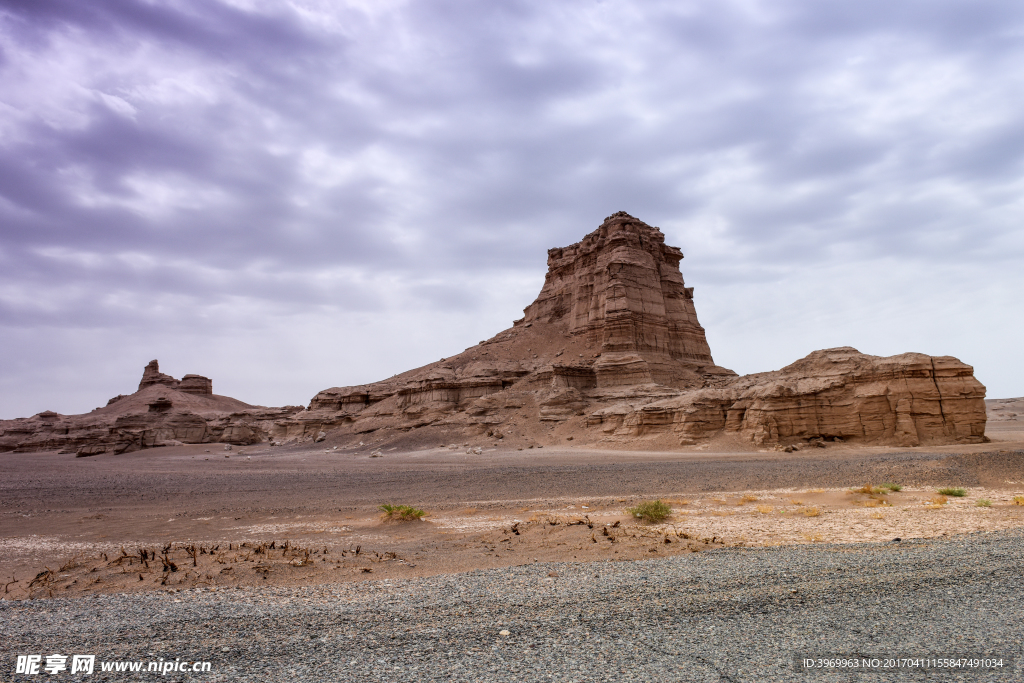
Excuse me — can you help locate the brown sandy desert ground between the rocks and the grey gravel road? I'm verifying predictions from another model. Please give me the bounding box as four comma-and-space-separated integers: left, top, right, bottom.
0, 407, 1024, 599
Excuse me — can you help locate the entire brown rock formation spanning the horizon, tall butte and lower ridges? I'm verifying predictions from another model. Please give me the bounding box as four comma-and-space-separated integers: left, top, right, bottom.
0, 212, 985, 455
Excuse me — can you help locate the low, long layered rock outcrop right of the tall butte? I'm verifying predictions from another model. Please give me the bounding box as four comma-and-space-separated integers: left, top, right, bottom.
588, 347, 985, 446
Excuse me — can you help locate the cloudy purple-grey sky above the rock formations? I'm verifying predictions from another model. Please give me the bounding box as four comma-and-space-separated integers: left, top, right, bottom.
0, 0, 1024, 419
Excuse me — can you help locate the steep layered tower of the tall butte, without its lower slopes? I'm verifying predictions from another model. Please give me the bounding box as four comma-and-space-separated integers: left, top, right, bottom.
520, 211, 720, 386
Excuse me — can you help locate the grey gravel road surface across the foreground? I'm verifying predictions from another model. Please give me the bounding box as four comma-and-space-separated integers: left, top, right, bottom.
0, 530, 1024, 681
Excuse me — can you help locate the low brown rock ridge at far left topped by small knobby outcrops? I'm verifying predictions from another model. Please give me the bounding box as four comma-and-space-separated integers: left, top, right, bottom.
0, 360, 302, 456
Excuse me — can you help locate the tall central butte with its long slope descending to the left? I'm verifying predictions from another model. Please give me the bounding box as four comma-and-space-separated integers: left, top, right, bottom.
275, 212, 735, 440
